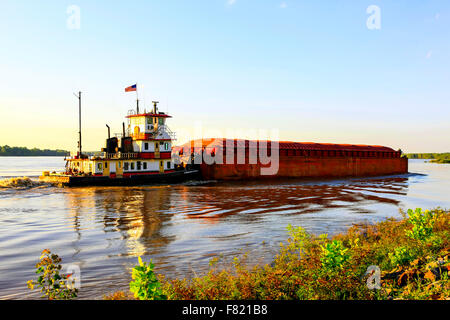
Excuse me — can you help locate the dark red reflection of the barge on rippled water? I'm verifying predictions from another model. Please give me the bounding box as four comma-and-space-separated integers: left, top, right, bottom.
179, 177, 408, 223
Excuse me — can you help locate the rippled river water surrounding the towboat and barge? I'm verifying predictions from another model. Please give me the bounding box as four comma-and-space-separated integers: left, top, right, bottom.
0, 157, 450, 299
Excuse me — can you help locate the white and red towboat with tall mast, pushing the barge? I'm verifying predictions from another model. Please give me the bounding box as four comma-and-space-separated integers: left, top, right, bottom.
39, 98, 199, 186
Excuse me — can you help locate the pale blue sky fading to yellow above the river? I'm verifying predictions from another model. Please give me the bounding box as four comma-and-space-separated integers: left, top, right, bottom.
0, 0, 450, 152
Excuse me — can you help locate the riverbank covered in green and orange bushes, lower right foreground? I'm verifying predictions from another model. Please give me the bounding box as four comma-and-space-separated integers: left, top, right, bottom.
105, 209, 450, 300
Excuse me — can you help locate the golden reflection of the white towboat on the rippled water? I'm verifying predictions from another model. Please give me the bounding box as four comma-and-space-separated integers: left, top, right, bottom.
65, 187, 173, 256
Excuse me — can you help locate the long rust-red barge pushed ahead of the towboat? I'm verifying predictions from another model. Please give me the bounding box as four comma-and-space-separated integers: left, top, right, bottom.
174, 139, 408, 180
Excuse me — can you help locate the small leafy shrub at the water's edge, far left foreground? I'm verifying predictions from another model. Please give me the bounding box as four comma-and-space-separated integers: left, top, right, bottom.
27, 249, 78, 300
